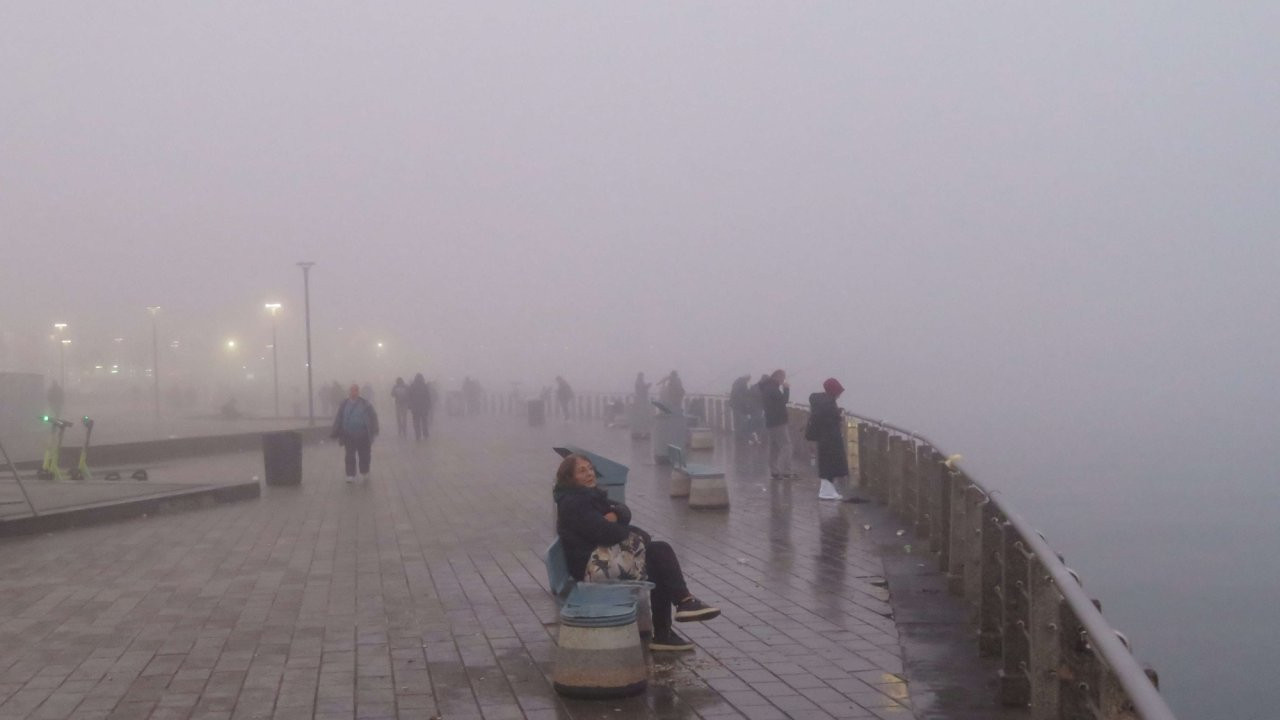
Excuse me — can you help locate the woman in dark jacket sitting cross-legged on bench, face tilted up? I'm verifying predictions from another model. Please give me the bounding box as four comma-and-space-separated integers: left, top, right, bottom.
553, 455, 719, 651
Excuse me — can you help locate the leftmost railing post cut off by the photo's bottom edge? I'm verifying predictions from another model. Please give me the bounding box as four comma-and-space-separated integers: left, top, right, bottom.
1027, 555, 1065, 720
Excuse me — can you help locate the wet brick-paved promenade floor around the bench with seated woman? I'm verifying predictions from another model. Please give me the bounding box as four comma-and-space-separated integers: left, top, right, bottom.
0, 416, 913, 720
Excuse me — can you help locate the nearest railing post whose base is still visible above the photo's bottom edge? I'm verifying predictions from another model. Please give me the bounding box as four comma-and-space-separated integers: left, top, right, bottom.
1000, 524, 1032, 707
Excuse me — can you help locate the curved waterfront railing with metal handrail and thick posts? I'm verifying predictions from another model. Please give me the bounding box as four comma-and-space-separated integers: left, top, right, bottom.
687, 395, 1175, 720
